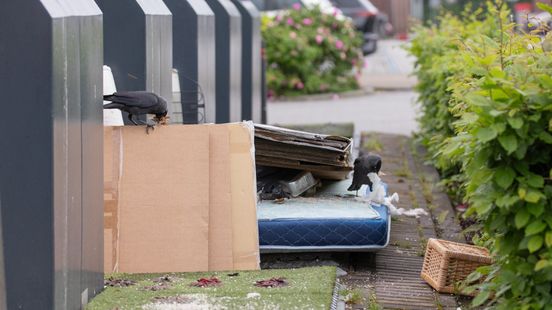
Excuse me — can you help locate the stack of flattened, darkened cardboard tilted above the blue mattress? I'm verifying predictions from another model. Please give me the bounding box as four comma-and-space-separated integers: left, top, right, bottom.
255, 124, 352, 180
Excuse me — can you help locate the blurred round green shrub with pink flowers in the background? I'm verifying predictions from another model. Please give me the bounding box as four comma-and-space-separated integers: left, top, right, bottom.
262, 4, 363, 96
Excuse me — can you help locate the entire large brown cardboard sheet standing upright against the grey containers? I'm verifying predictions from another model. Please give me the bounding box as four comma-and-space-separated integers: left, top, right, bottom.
104, 123, 259, 273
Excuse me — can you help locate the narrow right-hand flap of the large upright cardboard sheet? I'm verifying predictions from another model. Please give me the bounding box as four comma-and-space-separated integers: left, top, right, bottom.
228, 123, 260, 270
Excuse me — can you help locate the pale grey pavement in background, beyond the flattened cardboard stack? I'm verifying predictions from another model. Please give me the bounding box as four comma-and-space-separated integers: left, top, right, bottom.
267, 40, 418, 137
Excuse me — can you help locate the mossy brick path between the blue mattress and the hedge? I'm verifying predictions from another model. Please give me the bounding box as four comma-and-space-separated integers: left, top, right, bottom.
342, 134, 465, 310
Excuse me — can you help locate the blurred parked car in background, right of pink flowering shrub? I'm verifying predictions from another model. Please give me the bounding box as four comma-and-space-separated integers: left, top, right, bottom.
329, 0, 393, 55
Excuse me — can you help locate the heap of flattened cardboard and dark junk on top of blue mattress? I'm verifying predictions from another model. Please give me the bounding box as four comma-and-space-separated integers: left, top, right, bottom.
255, 124, 352, 201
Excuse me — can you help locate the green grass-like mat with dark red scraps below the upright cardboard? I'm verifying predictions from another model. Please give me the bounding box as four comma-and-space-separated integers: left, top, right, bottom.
86, 267, 336, 310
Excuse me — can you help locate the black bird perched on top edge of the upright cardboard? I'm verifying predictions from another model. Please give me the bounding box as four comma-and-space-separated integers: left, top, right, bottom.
103, 91, 169, 133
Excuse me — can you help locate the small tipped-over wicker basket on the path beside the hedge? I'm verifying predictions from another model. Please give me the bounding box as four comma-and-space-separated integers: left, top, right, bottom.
422, 239, 491, 294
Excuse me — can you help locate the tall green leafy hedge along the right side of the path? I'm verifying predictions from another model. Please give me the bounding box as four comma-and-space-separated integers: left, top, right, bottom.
410, 1, 552, 309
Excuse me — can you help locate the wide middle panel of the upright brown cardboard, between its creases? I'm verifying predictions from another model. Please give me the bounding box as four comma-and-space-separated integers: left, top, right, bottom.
118, 126, 209, 273
